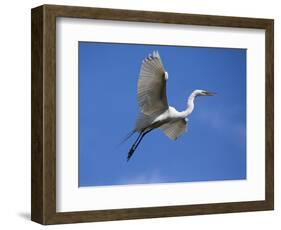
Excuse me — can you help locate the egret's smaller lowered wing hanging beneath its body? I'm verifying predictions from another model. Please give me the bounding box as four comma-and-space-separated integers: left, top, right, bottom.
160, 119, 187, 141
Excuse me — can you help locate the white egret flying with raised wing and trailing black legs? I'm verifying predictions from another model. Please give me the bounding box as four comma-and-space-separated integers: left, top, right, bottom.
127, 51, 215, 161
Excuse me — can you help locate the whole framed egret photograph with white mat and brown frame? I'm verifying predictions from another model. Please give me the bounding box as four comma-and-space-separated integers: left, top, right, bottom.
31, 5, 274, 224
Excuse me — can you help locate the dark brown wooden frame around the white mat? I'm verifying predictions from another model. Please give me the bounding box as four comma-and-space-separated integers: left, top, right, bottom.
31, 5, 274, 224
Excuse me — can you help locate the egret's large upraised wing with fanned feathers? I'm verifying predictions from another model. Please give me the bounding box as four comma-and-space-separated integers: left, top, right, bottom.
138, 51, 168, 115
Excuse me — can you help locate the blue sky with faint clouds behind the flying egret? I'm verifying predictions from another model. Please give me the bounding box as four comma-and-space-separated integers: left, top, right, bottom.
79, 42, 246, 186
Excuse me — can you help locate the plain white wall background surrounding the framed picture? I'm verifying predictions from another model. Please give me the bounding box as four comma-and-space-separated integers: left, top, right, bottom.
0, 0, 276, 230
